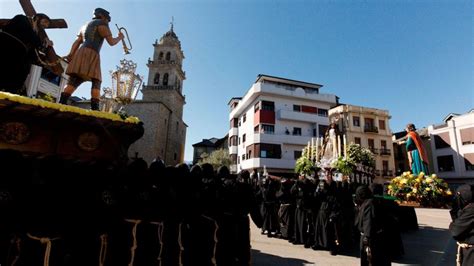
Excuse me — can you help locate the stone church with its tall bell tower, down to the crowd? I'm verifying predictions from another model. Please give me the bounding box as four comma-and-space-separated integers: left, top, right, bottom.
125, 25, 187, 165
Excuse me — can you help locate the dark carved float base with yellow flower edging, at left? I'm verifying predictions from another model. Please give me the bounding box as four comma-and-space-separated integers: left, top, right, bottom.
0, 92, 143, 162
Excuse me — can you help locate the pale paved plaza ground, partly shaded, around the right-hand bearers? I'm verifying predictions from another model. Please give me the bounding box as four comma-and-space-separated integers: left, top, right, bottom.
251, 208, 456, 266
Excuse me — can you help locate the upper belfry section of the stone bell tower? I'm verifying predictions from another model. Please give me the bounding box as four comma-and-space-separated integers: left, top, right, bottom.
142, 22, 186, 118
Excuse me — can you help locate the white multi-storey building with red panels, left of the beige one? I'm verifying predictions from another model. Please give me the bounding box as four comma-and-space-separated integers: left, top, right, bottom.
229, 75, 338, 174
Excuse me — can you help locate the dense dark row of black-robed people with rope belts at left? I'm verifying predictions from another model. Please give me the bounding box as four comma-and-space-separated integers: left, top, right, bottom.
0, 150, 258, 266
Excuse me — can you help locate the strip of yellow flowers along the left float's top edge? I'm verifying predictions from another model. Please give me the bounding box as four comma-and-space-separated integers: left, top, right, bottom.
0, 91, 140, 124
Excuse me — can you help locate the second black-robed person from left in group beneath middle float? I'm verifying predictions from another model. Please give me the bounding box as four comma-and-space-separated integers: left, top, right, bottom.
277, 178, 295, 240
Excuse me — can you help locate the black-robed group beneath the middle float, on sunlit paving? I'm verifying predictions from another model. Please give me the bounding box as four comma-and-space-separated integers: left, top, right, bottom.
251, 173, 404, 265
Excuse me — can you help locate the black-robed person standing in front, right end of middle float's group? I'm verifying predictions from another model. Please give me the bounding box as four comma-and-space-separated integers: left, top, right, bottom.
355, 185, 390, 266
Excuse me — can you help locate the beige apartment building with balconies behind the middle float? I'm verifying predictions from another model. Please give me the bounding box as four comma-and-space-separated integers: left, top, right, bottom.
329, 104, 395, 183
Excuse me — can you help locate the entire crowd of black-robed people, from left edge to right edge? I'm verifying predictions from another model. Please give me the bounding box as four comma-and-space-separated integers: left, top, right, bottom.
0, 150, 472, 266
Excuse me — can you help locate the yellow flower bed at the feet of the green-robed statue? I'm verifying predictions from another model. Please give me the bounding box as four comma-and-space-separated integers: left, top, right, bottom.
388, 172, 452, 207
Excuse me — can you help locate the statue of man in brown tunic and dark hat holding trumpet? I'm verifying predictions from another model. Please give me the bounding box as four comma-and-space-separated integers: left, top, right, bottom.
59, 8, 124, 110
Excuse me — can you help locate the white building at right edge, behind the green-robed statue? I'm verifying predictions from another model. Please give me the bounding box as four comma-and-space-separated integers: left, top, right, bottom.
428, 109, 474, 183
